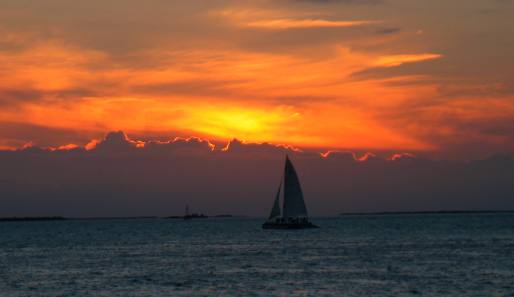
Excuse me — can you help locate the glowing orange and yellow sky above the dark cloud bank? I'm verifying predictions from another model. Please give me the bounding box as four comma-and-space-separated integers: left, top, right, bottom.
0, 0, 514, 159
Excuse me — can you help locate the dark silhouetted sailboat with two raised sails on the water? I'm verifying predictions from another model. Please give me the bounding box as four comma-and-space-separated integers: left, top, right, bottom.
262, 155, 319, 229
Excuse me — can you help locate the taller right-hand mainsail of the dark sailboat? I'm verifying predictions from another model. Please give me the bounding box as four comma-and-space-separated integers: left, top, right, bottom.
283, 156, 307, 219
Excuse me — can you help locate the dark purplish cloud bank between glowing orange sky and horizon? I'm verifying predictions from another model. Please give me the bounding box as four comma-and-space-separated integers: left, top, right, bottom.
0, 132, 514, 217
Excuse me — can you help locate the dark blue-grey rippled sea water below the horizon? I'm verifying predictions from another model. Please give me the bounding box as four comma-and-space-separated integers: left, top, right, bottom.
0, 214, 514, 296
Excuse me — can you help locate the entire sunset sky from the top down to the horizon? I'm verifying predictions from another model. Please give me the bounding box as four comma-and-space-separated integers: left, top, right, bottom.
0, 0, 514, 217
